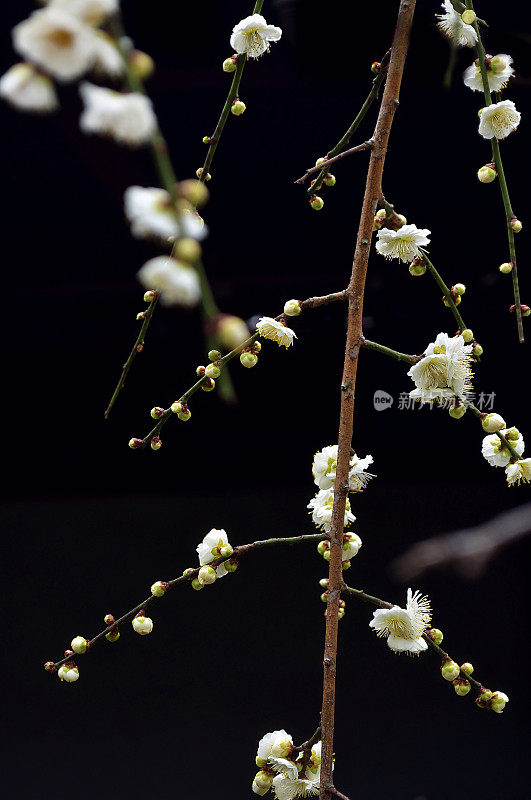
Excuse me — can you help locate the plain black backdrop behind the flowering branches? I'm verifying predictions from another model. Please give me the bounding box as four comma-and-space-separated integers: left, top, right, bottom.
0, 0, 531, 800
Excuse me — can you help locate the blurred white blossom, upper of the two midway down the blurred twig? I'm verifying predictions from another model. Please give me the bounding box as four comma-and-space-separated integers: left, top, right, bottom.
124, 186, 207, 241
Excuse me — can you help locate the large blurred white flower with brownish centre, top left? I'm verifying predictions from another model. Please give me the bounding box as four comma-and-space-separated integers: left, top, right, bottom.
13, 6, 95, 81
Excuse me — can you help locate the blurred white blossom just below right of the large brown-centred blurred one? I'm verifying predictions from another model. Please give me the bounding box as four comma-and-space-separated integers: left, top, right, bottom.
79, 82, 157, 147
